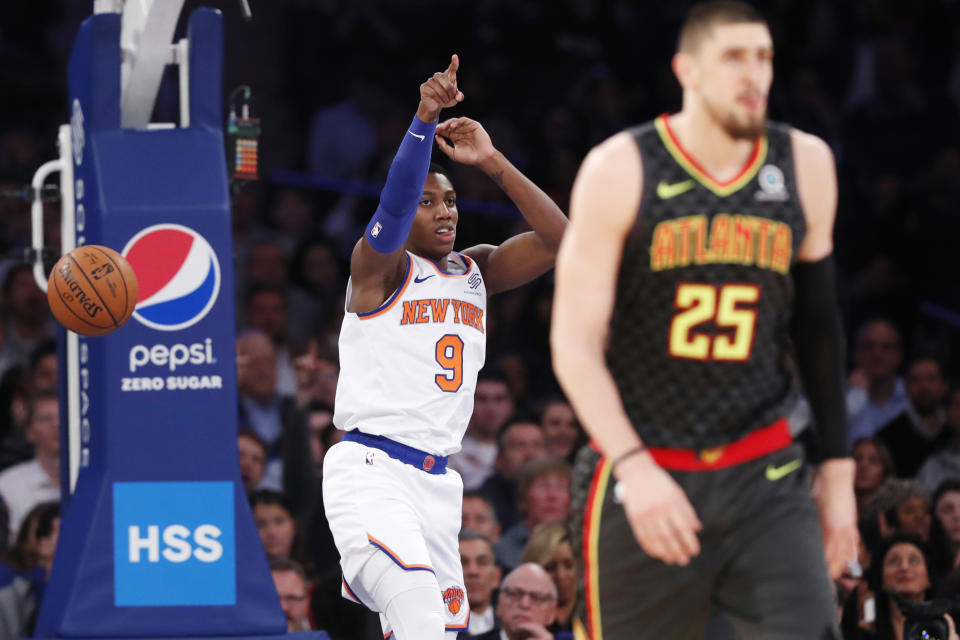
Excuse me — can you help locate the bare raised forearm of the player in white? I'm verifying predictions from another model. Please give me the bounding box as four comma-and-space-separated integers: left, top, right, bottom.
479, 151, 567, 251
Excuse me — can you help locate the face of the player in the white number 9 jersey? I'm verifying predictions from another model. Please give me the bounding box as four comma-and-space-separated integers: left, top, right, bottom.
407, 173, 458, 260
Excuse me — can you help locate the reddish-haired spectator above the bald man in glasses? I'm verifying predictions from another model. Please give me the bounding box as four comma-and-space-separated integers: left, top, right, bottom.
496, 457, 571, 568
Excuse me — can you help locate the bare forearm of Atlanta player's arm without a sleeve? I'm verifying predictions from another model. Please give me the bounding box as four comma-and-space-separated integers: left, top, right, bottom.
551, 330, 641, 459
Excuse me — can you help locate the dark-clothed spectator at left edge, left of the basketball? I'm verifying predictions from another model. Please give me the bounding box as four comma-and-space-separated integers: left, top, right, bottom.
0, 263, 53, 372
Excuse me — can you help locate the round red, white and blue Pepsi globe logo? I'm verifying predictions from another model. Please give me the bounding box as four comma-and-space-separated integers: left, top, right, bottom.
122, 224, 220, 331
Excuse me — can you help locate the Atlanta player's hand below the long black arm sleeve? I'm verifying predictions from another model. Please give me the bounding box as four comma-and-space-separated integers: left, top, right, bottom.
813, 458, 860, 579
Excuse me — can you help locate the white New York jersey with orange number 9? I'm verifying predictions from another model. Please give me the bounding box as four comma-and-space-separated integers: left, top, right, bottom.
333, 252, 487, 456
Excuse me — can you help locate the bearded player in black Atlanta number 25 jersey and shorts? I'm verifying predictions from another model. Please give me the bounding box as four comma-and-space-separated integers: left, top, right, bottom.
551, 2, 857, 640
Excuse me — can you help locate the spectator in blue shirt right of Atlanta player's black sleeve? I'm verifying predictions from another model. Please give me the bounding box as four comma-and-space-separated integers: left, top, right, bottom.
847, 318, 909, 441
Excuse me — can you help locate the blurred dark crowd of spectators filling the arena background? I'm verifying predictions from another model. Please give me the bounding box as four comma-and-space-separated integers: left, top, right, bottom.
0, 0, 960, 640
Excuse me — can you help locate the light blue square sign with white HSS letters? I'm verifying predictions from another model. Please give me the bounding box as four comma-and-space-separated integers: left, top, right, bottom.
113, 482, 237, 607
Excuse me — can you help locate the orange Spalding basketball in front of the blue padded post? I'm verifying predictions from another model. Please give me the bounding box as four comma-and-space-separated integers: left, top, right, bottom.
47, 244, 137, 336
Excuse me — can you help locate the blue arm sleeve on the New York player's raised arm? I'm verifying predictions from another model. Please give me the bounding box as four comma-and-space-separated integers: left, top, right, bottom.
364, 116, 437, 253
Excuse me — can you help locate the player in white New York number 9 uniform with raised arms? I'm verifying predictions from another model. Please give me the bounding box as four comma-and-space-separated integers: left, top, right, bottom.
323, 55, 567, 640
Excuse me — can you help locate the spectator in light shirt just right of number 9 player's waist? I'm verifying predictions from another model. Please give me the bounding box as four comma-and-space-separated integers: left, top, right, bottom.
449, 369, 513, 490
